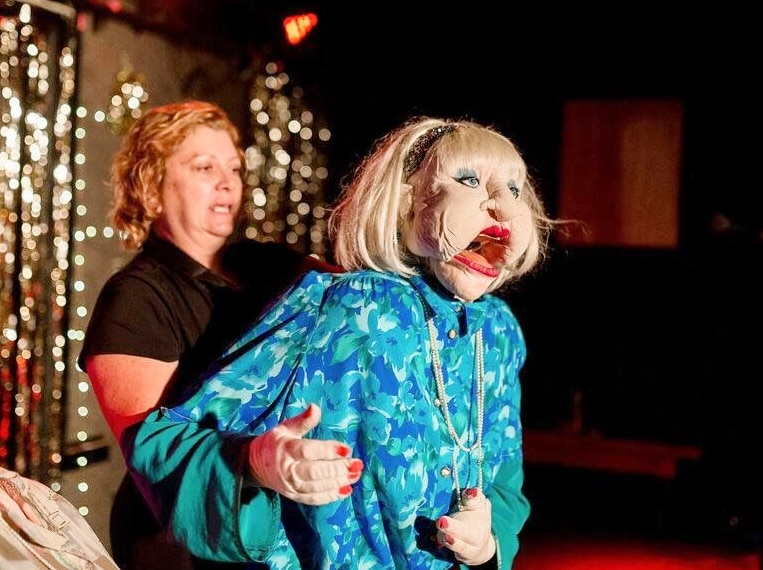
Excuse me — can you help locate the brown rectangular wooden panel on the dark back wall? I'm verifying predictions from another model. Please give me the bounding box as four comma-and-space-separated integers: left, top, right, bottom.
559, 100, 683, 248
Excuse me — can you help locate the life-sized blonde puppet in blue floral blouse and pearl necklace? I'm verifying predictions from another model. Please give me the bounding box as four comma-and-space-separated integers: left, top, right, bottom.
130, 118, 551, 570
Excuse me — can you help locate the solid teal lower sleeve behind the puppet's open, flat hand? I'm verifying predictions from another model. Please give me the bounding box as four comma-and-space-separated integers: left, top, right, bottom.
127, 411, 282, 562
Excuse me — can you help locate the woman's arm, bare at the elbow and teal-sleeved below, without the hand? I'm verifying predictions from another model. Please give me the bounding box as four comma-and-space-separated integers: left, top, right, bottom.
85, 354, 280, 562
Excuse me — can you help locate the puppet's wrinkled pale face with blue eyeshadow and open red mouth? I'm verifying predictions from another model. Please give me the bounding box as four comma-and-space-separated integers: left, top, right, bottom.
404, 151, 533, 301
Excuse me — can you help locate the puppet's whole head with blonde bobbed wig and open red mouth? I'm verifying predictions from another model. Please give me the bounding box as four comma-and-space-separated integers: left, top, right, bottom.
331, 117, 550, 301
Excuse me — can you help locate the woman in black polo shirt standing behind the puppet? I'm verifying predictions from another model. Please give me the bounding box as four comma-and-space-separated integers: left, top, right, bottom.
79, 101, 362, 570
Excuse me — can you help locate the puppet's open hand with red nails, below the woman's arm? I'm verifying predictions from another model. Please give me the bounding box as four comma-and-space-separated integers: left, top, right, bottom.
249, 404, 363, 505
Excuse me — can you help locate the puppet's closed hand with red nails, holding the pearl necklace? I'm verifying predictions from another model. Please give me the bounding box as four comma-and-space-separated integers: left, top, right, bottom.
437, 489, 496, 566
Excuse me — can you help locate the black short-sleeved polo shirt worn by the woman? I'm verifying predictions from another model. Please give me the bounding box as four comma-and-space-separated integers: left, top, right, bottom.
78, 235, 306, 404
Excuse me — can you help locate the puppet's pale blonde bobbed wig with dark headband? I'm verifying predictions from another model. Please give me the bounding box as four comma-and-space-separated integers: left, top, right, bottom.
329, 117, 553, 290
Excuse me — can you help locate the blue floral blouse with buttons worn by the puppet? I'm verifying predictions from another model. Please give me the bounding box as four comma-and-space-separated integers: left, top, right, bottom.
133, 270, 529, 570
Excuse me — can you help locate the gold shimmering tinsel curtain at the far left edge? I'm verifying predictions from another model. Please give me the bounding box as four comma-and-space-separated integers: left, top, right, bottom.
0, 4, 75, 488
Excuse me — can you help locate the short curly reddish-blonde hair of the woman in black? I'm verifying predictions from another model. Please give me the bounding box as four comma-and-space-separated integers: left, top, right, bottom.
110, 101, 243, 250
